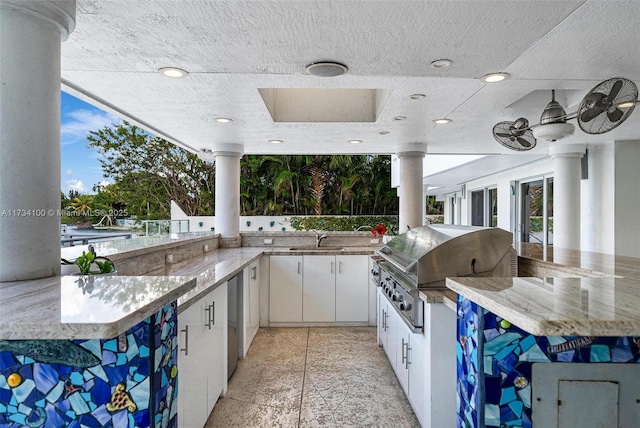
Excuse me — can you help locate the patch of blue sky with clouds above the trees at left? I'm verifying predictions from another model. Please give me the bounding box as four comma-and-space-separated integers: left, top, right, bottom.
60, 92, 121, 194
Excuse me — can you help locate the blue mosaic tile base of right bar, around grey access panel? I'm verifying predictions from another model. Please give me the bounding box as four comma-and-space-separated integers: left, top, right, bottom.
456, 295, 640, 428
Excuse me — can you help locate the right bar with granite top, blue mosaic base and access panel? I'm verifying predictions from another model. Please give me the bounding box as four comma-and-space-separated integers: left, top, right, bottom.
447, 277, 640, 428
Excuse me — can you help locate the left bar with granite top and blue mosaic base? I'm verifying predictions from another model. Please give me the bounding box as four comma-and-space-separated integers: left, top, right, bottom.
0, 276, 196, 427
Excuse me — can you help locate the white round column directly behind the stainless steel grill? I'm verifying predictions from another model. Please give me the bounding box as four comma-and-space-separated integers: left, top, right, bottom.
397, 145, 426, 233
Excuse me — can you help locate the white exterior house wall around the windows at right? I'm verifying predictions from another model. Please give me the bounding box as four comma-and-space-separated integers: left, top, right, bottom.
445, 141, 640, 257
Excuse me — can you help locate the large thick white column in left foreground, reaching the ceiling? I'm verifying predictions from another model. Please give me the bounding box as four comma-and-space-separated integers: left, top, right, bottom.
0, 0, 76, 282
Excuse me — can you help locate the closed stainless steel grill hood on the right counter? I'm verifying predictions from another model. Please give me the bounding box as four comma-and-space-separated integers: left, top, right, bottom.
379, 225, 513, 288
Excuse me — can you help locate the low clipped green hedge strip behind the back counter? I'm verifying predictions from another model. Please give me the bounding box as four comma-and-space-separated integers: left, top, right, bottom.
289, 215, 398, 235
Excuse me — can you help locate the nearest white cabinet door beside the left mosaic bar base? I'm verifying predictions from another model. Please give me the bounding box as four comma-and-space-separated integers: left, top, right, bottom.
178, 290, 215, 427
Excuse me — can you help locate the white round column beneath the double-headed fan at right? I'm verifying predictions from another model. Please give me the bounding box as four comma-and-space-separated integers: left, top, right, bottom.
549, 143, 585, 250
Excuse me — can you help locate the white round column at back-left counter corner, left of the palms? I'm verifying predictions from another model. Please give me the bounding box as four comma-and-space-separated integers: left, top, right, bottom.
214, 144, 244, 247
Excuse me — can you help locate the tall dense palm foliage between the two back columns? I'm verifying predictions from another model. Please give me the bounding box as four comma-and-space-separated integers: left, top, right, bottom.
240, 155, 398, 215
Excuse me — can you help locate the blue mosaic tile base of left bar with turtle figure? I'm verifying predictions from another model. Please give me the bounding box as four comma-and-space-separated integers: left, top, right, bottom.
0, 303, 178, 428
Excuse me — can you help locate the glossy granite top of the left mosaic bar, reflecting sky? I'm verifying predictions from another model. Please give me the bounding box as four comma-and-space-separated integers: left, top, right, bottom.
0, 275, 196, 340
